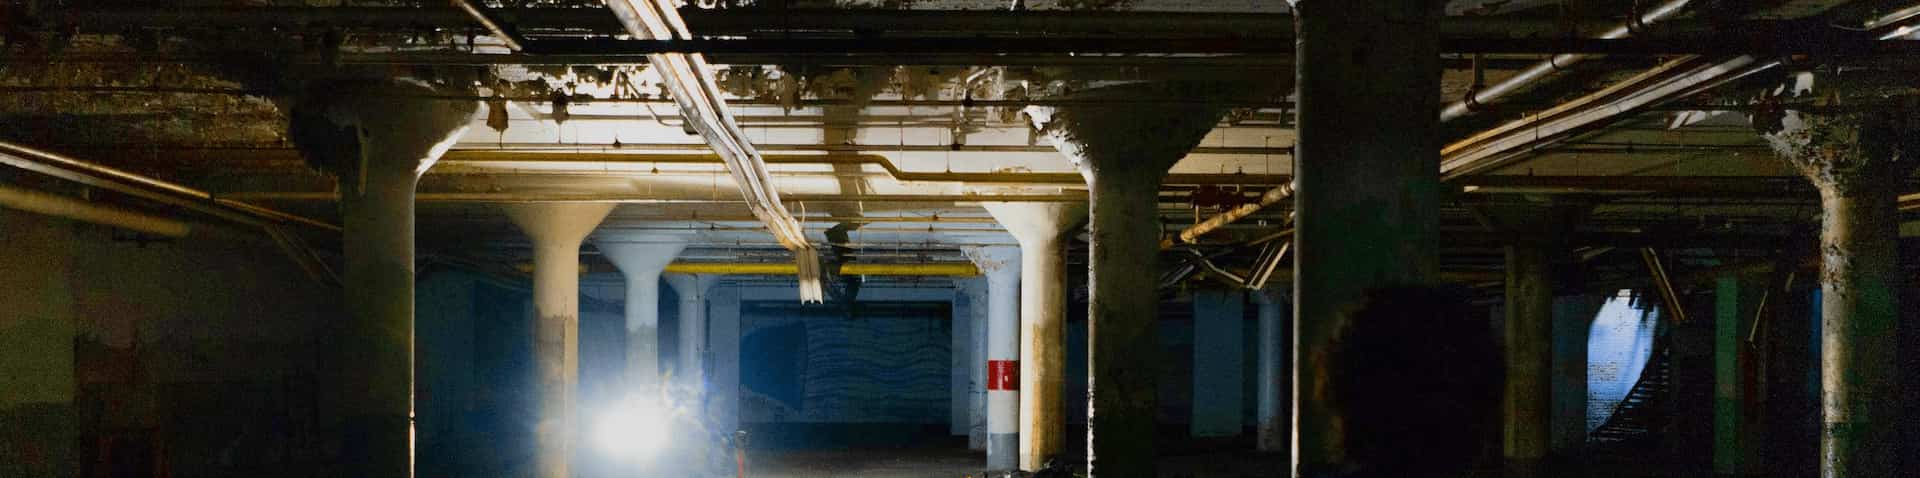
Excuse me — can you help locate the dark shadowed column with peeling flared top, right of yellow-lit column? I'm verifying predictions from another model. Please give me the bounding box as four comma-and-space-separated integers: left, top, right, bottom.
1025, 83, 1258, 476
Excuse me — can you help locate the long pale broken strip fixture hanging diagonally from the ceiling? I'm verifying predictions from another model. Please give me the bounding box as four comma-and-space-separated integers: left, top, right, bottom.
607, 0, 826, 303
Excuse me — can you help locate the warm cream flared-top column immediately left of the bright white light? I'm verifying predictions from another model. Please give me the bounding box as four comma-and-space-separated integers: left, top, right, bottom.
505, 203, 612, 478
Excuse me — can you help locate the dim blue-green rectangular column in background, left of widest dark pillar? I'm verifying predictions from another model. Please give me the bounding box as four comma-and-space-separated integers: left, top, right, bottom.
1190, 290, 1246, 438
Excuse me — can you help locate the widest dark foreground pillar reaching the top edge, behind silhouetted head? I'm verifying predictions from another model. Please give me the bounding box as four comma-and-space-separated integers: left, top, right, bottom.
1292, 0, 1440, 476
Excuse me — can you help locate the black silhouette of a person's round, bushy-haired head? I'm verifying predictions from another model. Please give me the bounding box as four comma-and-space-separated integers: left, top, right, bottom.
1319, 288, 1505, 478
